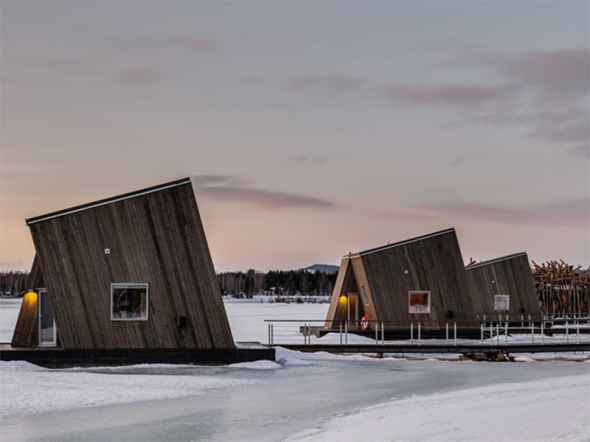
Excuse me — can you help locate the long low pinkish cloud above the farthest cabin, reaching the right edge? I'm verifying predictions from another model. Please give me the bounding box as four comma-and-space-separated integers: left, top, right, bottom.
416, 198, 590, 227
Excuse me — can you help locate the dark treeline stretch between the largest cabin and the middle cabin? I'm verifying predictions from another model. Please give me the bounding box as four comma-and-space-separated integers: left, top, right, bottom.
217, 269, 336, 296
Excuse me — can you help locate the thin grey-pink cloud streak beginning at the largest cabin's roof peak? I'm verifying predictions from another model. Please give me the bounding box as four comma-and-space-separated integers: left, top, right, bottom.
191, 175, 336, 210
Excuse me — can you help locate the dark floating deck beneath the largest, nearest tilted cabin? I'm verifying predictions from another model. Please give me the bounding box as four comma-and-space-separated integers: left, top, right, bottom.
0, 344, 275, 367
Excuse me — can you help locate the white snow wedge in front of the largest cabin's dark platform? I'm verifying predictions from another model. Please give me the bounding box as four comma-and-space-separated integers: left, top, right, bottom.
0, 361, 260, 418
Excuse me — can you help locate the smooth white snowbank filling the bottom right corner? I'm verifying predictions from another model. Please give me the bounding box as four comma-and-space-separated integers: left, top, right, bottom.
288, 376, 590, 442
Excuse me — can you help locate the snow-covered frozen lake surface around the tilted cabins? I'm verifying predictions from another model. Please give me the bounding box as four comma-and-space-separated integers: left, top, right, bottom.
0, 301, 590, 441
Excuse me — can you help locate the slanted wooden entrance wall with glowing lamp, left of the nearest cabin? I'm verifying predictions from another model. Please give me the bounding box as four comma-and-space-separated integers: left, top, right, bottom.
10, 256, 43, 347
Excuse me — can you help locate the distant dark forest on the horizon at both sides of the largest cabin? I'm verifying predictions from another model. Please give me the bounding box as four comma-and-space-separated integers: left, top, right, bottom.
0, 270, 336, 296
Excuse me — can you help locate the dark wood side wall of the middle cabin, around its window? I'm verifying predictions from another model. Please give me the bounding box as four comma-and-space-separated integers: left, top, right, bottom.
361, 229, 479, 325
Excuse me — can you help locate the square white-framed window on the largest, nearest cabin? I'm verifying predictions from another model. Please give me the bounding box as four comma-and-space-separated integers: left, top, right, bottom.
111, 283, 149, 321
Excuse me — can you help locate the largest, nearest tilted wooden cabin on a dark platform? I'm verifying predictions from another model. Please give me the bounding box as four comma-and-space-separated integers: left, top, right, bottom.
12, 178, 234, 349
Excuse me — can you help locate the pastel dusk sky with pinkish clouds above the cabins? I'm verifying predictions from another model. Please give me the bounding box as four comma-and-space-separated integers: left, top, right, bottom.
0, 1, 590, 271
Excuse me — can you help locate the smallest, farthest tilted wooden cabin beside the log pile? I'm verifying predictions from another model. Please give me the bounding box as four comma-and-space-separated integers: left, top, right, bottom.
465, 253, 541, 319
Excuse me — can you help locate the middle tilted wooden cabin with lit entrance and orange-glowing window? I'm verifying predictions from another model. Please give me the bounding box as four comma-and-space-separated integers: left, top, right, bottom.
326, 229, 481, 328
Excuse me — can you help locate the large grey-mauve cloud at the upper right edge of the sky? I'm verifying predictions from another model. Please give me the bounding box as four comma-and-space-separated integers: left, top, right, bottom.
444, 46, 590, 157
